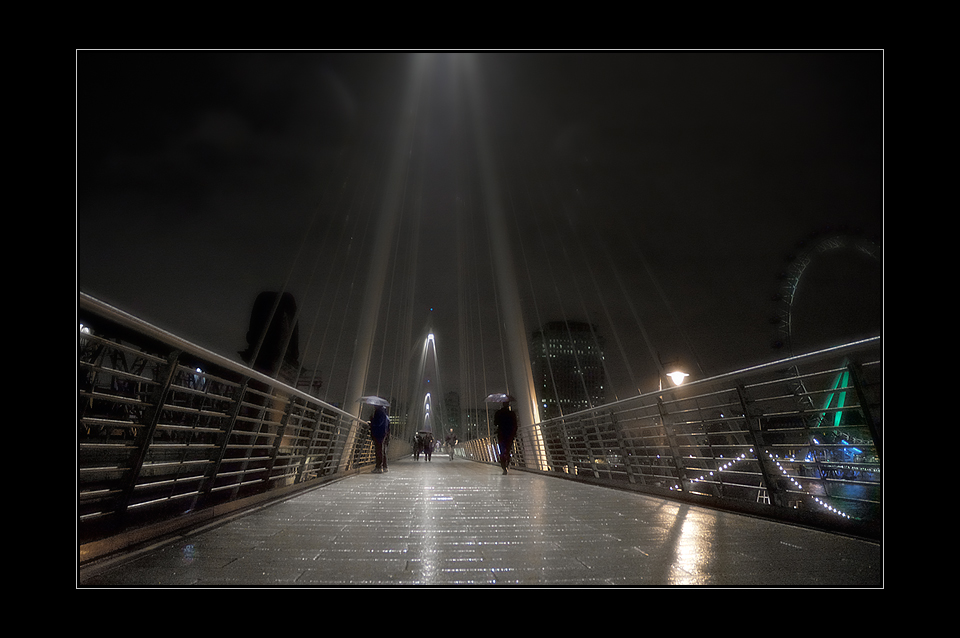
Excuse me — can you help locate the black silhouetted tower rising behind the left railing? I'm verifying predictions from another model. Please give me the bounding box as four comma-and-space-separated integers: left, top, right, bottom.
240, 291, 300, 377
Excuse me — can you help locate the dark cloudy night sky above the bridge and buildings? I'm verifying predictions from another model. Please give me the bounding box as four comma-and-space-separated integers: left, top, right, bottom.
76, 51, 884, 410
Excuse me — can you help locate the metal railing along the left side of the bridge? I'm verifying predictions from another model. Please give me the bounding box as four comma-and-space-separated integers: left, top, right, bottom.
77, 294, 373, 560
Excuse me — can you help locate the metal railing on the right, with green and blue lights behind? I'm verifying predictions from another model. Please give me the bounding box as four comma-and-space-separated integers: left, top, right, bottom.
460, 337, 883, 538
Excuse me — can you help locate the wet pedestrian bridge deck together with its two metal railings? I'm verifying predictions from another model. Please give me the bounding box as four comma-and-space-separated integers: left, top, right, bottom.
77, 295, 883, 587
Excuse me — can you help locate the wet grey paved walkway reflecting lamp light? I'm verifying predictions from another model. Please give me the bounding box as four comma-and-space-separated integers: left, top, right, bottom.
78, 456, 883, 588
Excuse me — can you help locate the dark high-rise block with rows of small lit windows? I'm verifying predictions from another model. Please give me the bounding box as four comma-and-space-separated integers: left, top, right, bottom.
530, 321, 606, 420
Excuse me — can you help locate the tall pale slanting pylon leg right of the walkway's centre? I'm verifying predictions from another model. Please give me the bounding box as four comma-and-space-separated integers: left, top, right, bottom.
457, 54, 546, 469
